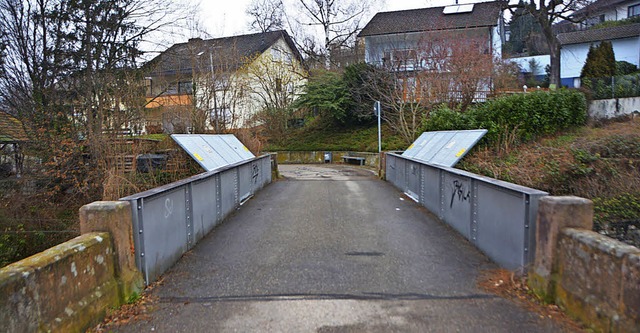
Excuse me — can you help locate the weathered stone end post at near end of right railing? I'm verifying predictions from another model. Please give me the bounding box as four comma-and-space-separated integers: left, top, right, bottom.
529, 196, 593, 301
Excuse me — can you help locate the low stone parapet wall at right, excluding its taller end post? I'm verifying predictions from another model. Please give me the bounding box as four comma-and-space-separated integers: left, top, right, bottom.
555, 228, 640, 332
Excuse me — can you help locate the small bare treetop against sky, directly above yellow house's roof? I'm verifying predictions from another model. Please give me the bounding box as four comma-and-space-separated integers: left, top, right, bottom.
245, 0, 284, 32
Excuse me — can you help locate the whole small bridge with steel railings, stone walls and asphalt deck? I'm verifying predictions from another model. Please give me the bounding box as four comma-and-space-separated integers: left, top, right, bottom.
0, 149, 640, 332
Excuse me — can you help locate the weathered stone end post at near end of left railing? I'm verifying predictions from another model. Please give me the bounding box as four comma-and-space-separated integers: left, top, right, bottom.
80, 201, 144, 302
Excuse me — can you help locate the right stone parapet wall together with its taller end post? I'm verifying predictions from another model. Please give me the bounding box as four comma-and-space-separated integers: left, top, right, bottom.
529, 197, 640, 332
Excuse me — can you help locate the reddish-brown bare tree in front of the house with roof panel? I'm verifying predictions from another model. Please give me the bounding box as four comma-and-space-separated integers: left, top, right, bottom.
364, 32, 494, 143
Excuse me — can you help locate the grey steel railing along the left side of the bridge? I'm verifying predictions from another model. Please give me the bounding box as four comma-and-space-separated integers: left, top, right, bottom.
120, 155, 271, 284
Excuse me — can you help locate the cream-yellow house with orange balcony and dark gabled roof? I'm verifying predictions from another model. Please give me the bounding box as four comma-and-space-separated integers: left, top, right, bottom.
146, 30, 306, 133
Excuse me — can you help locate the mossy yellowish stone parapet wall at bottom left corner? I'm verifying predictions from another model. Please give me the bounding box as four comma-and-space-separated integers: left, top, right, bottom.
0, 233, 121, 332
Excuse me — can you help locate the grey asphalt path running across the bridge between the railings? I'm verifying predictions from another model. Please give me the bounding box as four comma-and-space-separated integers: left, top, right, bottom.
117, 165, 560, 332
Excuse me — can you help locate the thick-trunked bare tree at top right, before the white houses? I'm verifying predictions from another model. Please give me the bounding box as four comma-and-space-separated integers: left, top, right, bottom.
504, 0, 593, 86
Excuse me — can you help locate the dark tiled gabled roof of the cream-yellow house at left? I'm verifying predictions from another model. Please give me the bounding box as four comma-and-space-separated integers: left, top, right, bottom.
147, 30, 302, 74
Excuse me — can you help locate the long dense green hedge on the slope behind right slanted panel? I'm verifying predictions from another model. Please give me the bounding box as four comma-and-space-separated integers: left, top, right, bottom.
423, 90, 587, 145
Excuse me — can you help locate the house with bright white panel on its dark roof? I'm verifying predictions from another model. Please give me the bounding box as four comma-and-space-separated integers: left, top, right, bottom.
358, 1, 504, 102
